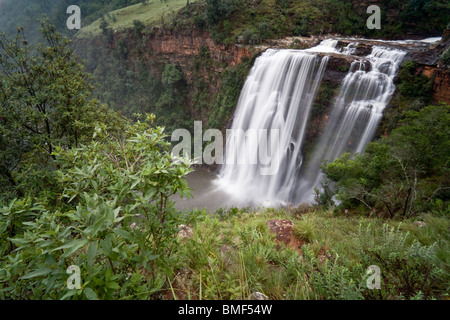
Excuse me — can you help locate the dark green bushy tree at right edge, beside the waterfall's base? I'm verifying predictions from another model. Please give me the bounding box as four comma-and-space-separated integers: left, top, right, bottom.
323, 104, 450, 218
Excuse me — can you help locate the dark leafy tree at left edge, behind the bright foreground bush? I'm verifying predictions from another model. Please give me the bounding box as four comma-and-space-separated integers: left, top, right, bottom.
0, 19, 123, 200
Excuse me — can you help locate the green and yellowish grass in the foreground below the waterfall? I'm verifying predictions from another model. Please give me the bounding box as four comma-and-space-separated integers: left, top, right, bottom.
166, 209, 450, 299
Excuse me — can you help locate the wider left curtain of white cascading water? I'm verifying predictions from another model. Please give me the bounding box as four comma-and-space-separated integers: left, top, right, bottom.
220, 49, 328, 203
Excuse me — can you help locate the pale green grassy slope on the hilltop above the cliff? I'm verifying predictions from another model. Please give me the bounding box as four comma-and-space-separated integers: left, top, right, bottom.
77, 0, 195, 38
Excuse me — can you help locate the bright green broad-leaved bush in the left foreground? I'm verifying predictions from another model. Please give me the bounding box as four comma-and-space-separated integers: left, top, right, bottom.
0, 117, 191, 299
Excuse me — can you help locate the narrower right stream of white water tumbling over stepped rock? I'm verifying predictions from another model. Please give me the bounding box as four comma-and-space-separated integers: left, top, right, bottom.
295, 46, 406, 202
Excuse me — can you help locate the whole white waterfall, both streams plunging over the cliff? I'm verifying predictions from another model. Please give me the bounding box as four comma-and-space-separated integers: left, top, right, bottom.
219, 40, 405, 205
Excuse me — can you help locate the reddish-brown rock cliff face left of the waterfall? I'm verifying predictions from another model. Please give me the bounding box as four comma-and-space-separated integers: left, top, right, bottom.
74, 28, 258, 124
